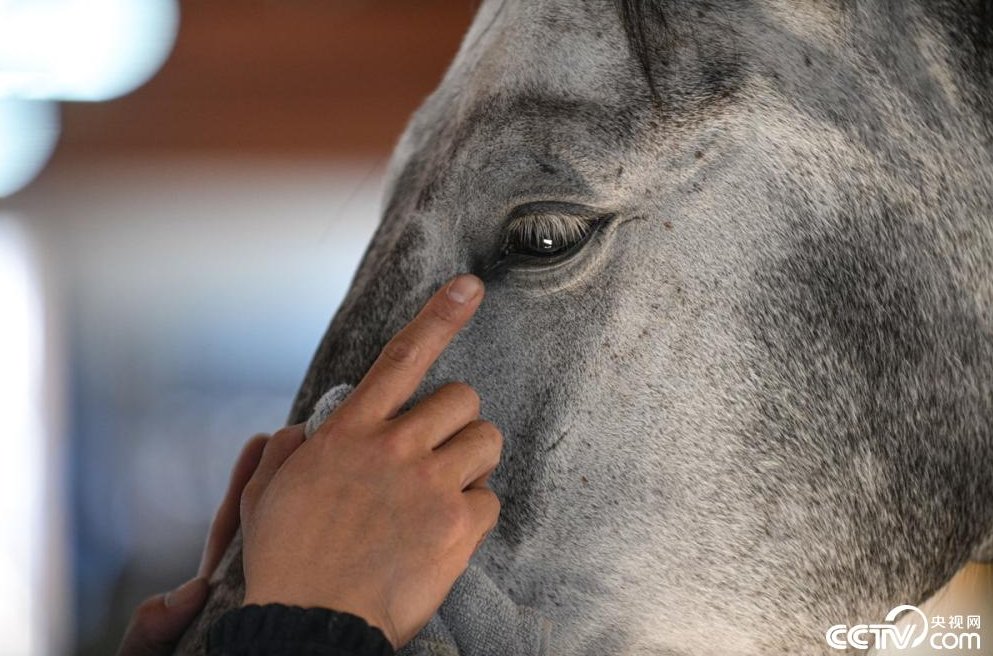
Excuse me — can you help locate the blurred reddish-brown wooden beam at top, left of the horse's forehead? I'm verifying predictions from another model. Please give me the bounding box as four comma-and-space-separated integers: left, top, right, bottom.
59, 0, 475, 157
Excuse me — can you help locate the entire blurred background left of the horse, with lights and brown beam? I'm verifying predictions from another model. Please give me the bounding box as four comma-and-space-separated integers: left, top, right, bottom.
0, 0, 474, 655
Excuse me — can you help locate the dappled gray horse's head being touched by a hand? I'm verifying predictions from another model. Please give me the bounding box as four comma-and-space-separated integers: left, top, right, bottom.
176, 0, 993, 655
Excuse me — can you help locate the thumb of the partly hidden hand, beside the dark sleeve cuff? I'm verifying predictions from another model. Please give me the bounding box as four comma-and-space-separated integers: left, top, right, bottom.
117, 577, 207, 656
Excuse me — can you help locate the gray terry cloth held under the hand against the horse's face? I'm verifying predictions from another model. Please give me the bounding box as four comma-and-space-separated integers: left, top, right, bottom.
304, 385, 551, 656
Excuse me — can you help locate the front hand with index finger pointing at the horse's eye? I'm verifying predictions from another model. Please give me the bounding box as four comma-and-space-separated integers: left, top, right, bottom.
241, 275, 502, 648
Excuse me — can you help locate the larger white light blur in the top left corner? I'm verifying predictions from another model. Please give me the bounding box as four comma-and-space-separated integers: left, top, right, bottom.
0, 0, 179, 100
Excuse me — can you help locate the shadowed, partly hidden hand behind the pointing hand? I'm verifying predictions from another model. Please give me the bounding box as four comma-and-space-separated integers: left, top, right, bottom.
117, 435, 268, 656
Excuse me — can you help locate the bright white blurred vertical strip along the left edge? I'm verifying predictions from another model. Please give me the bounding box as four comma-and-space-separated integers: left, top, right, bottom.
0, 217, 50, 655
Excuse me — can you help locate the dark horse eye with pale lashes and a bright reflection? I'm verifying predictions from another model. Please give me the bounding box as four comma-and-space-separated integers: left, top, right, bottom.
503, 203, 603, 258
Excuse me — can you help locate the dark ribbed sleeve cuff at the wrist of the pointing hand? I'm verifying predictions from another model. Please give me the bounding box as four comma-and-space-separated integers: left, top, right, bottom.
207, 604, 393, 656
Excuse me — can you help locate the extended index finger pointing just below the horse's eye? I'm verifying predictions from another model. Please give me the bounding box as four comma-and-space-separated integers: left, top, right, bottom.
346, 274, 483, 419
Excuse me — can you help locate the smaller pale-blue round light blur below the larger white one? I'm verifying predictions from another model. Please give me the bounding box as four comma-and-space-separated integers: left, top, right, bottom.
0, 97, 59, 197
